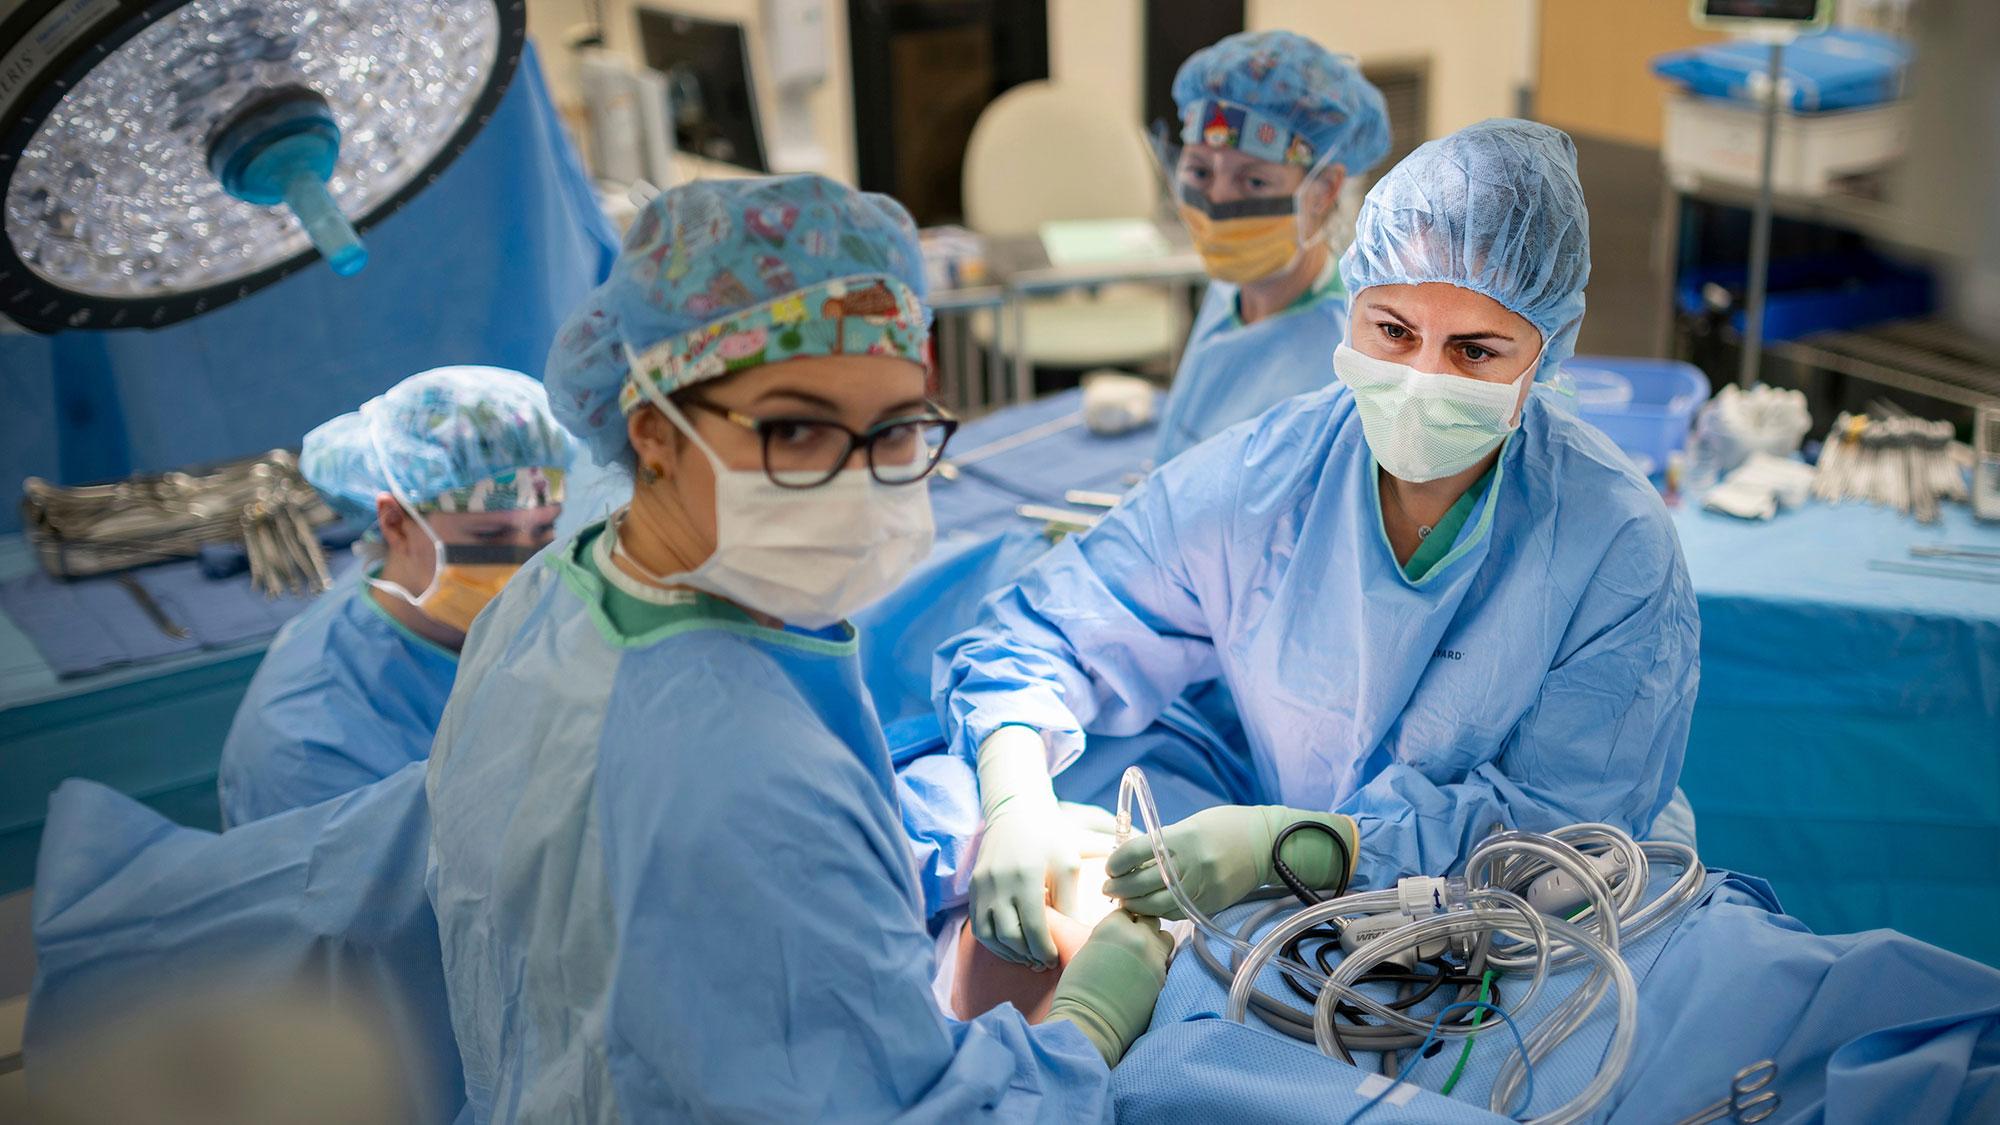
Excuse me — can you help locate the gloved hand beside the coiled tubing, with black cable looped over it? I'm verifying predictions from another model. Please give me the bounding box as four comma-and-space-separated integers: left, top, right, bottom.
1104, 805, 1356, 919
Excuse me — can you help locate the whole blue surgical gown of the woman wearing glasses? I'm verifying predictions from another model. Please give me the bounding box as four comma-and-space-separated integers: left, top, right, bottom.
428, 526, 1110, 1121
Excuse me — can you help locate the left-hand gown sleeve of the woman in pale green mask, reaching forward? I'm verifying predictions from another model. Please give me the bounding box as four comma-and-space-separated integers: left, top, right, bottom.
932, 438, 1242, 773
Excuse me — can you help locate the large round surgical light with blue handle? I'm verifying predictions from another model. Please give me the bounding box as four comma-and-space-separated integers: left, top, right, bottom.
0, 0, 526, 332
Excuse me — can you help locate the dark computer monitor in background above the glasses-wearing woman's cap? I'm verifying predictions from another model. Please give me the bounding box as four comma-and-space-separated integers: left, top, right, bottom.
638, 8, 770, 172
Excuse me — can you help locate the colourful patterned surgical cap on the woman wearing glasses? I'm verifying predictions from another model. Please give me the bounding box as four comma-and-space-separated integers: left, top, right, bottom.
548, 176, 930, 464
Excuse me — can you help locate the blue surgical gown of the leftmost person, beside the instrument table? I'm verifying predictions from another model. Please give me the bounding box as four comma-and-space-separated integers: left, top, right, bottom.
220, 581, 458, 827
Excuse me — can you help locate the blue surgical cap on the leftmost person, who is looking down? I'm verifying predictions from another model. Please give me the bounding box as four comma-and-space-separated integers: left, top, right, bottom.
298, 366, 576, 524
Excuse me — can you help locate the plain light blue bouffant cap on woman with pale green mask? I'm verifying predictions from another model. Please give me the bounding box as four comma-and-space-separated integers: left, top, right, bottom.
1340, 118, 1590, 378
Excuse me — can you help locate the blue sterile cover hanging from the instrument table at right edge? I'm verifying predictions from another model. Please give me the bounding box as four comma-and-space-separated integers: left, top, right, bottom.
1674, 502, 2000, 965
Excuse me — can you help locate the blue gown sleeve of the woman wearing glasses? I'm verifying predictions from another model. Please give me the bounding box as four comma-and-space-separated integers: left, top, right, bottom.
598, 652, 1110, 1121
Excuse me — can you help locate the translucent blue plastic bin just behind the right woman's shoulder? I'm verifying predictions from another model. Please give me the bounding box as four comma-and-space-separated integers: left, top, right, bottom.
1562, 356, 1708, 476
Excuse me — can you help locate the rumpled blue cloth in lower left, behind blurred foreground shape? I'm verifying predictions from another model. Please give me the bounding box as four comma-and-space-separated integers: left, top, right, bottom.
24, 765, 466, 1125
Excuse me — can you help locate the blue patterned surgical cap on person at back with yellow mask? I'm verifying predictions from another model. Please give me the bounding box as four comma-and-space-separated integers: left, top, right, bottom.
1174, 32, 1388, 176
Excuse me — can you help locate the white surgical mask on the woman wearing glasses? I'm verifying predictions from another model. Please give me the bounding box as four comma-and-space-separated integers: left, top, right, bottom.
612, 388, 936, 629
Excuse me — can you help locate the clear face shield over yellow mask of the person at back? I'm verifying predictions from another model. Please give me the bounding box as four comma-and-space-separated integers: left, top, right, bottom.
1146, 122, 1346, 284
